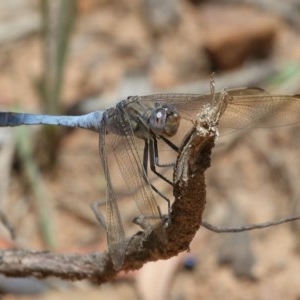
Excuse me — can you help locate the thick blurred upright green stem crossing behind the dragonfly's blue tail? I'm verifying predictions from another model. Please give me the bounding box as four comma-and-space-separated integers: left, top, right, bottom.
38, 0, 77, 167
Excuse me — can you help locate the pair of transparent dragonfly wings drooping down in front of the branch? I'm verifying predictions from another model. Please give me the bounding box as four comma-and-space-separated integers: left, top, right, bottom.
100, 109, 164, 266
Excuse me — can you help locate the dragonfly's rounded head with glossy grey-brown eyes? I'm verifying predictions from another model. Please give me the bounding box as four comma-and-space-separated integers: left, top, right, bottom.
149, 104, 180, 137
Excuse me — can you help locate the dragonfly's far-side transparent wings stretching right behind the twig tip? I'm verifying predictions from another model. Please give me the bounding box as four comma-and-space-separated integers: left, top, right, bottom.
140, 88, 300, 132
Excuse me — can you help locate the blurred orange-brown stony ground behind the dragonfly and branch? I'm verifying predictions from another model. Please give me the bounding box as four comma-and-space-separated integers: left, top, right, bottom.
0, 0, 300, 299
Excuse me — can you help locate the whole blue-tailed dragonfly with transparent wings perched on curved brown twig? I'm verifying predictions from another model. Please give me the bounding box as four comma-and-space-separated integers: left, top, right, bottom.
0, 84, 300, 270
